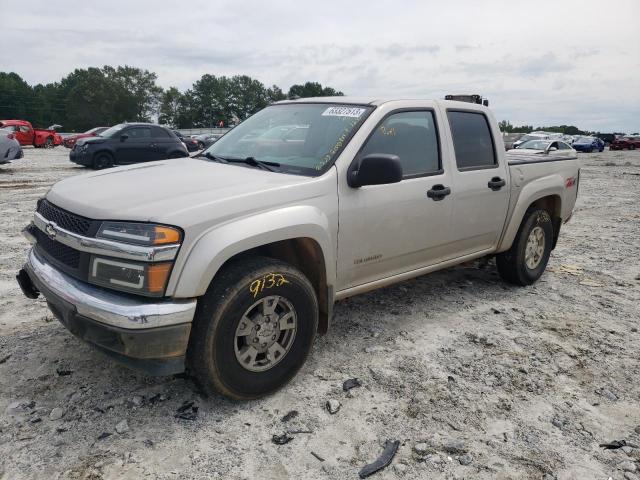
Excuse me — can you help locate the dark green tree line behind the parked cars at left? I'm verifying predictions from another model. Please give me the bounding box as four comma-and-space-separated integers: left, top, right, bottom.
0, 65, 344, 131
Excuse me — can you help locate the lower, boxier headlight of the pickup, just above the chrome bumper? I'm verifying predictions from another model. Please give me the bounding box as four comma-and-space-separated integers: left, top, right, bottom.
89, 256, 173, 297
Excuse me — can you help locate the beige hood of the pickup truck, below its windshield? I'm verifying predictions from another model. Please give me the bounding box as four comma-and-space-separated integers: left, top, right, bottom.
47, 158, 322, 228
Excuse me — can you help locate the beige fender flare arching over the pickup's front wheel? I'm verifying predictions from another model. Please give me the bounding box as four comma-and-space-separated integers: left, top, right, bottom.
167, 205, 336, 298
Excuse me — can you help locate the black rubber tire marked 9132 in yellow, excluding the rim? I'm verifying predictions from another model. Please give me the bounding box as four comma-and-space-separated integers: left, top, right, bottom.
188, 257, 318, 400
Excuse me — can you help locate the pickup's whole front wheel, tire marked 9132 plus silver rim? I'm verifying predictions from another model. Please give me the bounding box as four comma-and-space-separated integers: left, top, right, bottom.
189, 257, 318, 400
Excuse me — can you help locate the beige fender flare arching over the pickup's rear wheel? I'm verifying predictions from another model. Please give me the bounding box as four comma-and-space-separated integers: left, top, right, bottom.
497, 174, 564, 252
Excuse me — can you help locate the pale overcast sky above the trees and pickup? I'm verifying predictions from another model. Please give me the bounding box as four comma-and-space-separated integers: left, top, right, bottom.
0, 0, 640, 133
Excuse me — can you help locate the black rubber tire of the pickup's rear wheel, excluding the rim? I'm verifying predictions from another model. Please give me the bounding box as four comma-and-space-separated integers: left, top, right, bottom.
496, 208, 553, 286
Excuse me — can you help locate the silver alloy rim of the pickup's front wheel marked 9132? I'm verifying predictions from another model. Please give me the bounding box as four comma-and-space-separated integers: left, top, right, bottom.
233, 295, 298, 372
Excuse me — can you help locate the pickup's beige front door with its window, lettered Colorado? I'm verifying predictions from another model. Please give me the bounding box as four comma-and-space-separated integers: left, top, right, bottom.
338, 108, 453, 289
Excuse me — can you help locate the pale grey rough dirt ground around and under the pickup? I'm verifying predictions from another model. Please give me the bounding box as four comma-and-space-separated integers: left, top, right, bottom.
0, 147, 640, 480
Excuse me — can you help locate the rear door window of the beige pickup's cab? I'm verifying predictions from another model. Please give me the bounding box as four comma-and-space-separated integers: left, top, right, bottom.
447, 110, 497, 170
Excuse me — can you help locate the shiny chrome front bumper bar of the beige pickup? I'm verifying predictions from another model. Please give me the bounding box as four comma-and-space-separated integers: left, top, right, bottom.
24, 249, 197, 330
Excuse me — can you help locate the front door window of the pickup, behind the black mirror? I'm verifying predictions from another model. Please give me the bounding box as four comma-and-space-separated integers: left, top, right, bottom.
360, 111, 440, 178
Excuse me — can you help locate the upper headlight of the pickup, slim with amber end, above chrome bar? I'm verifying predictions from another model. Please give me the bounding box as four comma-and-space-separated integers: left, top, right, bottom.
98, 222, 182, 245
